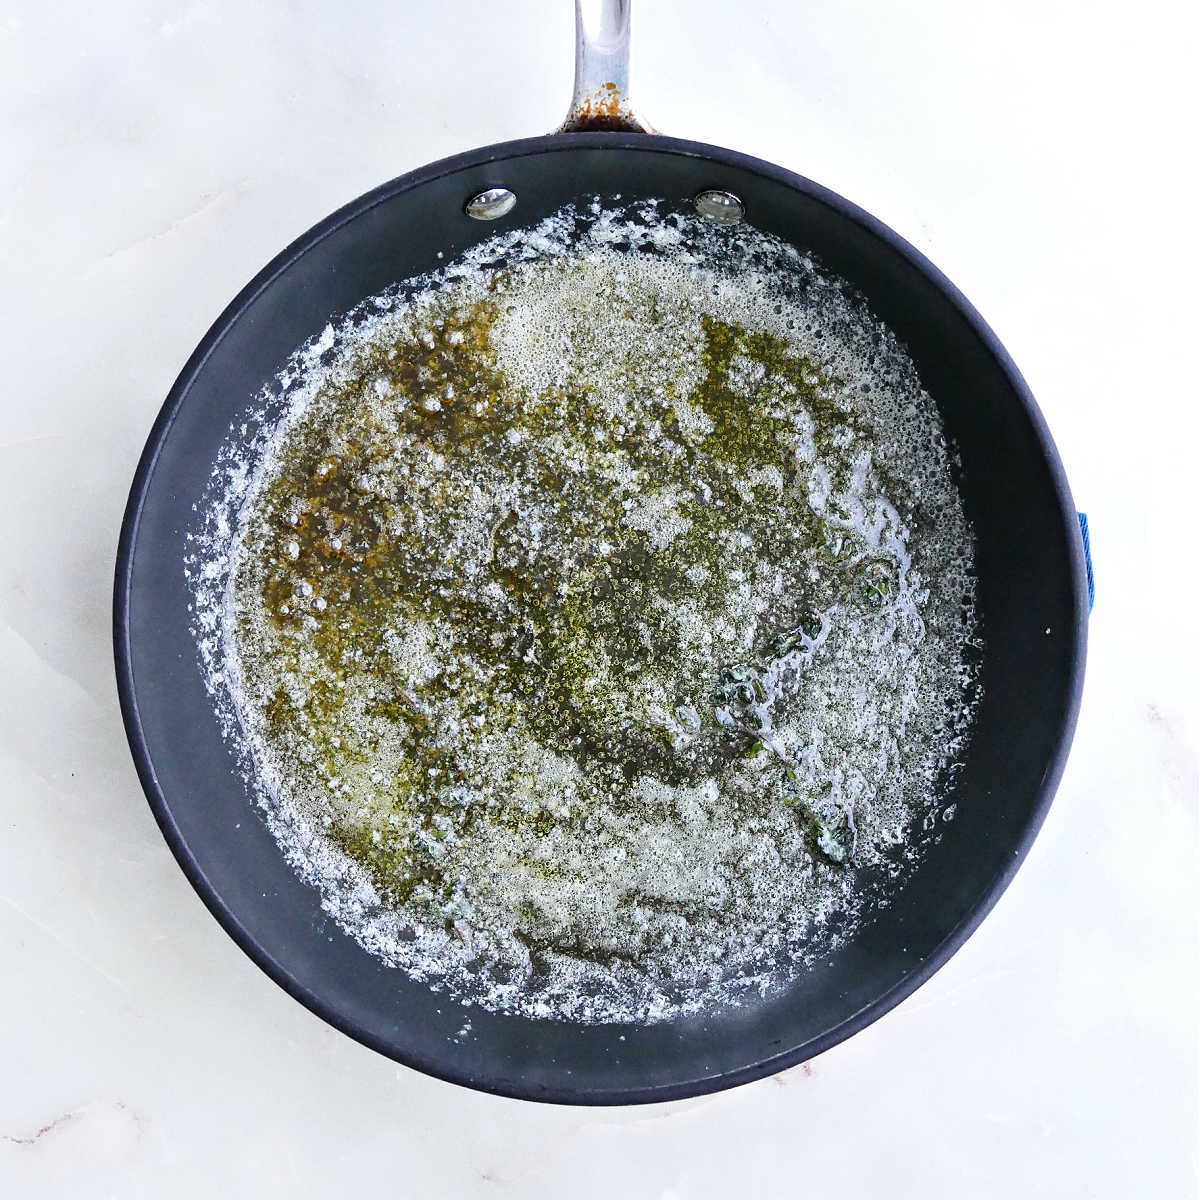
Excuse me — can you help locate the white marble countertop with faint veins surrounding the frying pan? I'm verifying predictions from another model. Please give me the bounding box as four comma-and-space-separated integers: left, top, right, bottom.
0, 0, 1198, 1200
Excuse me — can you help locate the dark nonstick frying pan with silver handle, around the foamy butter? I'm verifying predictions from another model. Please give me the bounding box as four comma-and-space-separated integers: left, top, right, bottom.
114, 0, 1087, 1104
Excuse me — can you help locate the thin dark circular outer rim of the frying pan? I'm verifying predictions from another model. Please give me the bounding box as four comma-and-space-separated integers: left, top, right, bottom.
113, 133, 1087, 1105
